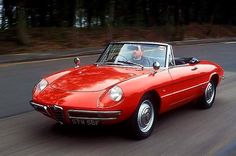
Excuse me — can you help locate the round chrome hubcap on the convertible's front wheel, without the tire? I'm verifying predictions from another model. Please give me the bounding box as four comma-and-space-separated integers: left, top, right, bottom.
137, 100, 154, 132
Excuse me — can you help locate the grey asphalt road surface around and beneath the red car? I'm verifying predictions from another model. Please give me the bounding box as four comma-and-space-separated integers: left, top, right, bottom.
0, 43, 236, 156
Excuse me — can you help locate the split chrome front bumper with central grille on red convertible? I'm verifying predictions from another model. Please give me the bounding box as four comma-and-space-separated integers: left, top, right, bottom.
30, 101, 121, 123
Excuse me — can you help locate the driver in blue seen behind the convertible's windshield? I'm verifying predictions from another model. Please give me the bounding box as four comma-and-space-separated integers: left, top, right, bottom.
132, 45, 151, 67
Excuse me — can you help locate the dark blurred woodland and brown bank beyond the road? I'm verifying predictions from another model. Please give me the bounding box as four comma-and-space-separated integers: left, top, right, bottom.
0, 0, 236, 54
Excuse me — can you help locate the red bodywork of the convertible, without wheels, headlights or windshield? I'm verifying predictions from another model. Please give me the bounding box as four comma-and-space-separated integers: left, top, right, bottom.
31, 42, 224, 139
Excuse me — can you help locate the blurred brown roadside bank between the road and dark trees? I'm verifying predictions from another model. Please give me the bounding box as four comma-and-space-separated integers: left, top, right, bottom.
0, 23, 236, 54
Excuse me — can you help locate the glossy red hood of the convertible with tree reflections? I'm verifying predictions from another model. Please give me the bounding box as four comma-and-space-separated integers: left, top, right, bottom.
51, 65, 150, 92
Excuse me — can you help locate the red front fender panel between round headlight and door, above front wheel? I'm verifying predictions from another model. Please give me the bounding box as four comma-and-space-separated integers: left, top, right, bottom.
114, 70, 171, 119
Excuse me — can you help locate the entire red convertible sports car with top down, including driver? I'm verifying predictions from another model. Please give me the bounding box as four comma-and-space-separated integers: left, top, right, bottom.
30, 42, 224, 139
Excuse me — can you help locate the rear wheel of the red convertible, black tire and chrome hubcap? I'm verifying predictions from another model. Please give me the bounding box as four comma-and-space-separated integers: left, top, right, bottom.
200, 81, 216, 109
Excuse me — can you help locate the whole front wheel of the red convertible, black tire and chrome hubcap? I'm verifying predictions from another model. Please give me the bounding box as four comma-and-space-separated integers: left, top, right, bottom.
127, 95, 157, 140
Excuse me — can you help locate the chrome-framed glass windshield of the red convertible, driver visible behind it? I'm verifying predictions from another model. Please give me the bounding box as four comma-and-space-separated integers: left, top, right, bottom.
97, 43, 167, 67
